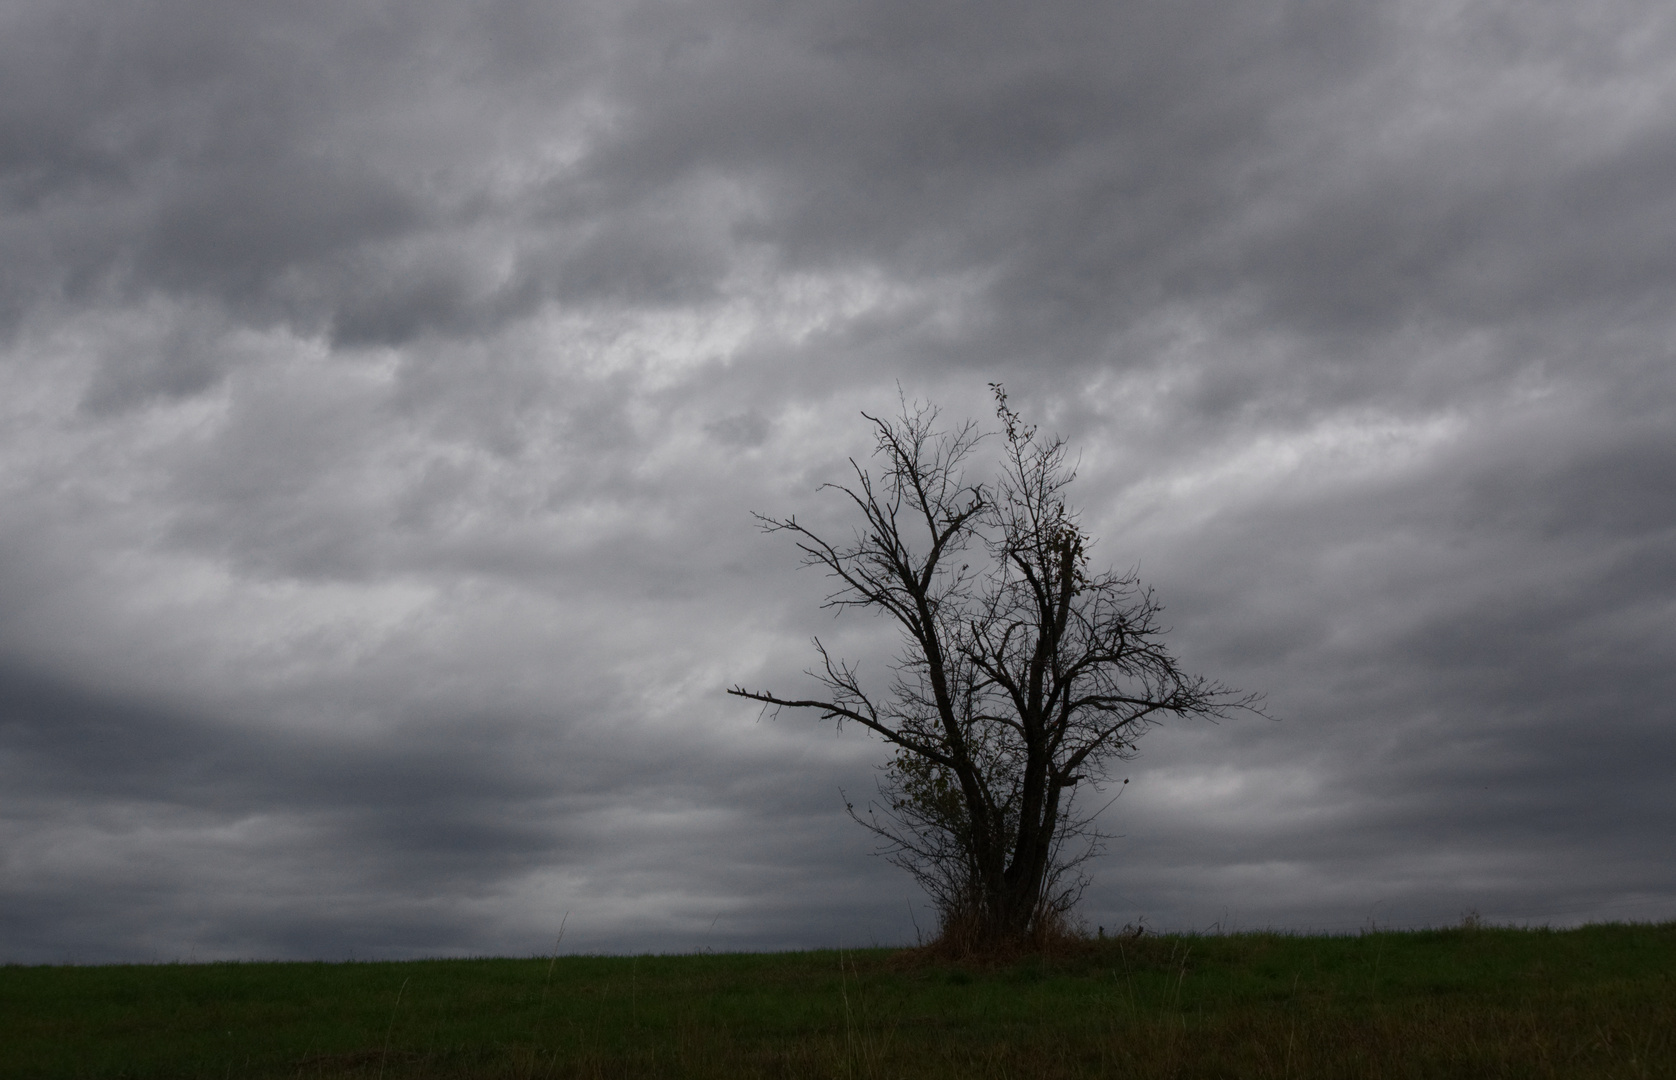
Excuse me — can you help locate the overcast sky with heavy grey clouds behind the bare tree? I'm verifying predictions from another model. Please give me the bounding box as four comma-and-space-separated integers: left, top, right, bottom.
0, 0, 1676, 963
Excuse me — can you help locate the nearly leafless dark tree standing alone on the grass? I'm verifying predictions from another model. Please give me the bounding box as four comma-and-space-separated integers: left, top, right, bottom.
729, 386, 1254, 944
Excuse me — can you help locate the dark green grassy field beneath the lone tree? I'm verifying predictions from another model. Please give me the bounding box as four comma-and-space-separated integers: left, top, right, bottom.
0, 924, 1676, 1080
